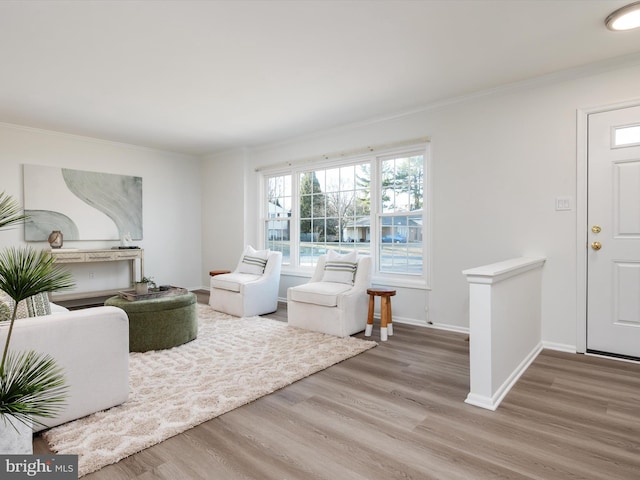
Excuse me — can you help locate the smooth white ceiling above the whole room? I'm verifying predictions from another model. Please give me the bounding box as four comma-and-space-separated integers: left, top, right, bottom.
0, 0, 640, 154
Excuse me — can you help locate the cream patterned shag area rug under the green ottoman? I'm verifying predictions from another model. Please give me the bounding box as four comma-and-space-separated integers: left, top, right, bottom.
43, 304, 377, 476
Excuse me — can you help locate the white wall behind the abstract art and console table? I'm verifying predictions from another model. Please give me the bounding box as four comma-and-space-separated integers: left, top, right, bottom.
0, 124, 202, 291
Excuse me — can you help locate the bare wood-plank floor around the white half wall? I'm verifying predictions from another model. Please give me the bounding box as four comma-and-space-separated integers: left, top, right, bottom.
34, 296, 640, 480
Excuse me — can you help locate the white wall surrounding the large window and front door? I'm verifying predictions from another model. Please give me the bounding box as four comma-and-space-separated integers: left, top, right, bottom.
204, 65, 640, 349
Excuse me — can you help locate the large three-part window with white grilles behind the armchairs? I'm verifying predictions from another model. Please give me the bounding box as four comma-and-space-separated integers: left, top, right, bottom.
263, 145, 425, 277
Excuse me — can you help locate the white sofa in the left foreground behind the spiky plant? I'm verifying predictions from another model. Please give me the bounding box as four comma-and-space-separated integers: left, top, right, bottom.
0, 304, 129, 431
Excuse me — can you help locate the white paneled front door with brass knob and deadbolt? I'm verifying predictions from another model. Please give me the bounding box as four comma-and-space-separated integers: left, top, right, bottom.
587, 107, 640, 358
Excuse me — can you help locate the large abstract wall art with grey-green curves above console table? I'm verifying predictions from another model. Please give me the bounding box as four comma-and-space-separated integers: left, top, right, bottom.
23, 165, 142, 242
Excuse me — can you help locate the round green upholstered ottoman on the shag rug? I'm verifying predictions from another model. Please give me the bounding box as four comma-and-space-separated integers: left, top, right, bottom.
104, 292, 198, 352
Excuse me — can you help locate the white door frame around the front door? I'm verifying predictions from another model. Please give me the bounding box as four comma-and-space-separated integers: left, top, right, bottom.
576, 98, 640, 353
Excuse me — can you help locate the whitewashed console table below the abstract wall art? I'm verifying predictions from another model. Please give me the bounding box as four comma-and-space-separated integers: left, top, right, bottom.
51, 248, 144, 300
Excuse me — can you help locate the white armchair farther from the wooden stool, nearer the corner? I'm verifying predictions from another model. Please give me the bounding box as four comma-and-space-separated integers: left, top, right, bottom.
209, 246, 282, 317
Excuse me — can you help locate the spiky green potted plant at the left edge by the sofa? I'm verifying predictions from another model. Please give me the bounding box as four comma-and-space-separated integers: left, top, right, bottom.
0, 192, 73, 453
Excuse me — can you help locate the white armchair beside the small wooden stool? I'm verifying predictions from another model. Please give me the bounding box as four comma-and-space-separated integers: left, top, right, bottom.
287, 255, 371, 337
